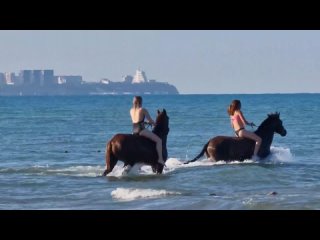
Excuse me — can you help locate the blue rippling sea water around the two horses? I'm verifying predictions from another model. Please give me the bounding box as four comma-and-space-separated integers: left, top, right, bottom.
0, 94, 320, 210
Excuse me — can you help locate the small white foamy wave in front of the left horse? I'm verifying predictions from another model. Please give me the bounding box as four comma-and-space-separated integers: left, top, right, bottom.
111, 188, 181, 201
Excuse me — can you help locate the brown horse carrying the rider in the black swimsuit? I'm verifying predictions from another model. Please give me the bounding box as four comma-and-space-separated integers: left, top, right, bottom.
103, 109, 169, 176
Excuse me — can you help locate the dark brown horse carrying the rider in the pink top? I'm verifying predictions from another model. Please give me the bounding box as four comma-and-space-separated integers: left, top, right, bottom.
185, 113, 287, 164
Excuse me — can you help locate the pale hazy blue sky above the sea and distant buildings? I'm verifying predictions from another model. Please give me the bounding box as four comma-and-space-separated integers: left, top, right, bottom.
0, 30, 320, 94
